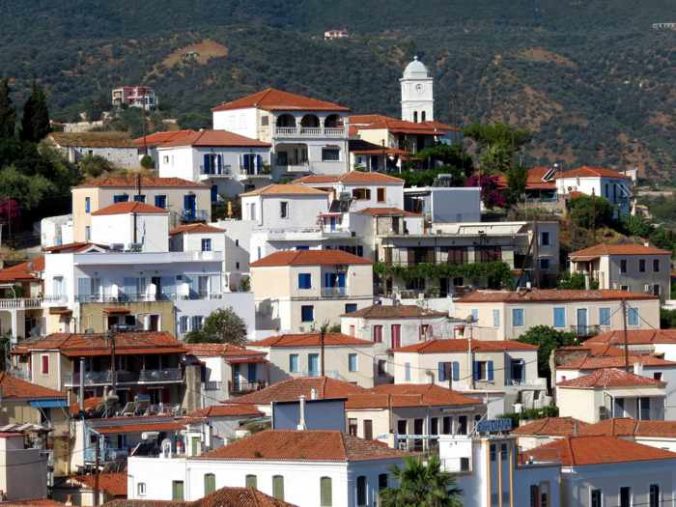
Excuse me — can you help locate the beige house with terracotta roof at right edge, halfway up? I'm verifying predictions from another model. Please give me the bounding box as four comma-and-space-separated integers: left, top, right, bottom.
568, 244, 671, 301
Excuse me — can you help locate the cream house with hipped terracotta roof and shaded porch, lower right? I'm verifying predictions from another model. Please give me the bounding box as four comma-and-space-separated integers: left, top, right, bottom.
556, 368, 666, 423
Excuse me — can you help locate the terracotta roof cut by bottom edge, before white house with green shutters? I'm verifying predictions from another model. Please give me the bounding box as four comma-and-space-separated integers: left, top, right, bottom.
104, 488, 294, 507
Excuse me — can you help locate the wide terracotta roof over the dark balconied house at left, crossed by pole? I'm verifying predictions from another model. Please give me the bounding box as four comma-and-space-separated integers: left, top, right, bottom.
12, 331, 187, 357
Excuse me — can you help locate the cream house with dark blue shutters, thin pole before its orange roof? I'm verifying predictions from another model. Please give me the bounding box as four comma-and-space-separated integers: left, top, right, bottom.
393, 338, 548, 417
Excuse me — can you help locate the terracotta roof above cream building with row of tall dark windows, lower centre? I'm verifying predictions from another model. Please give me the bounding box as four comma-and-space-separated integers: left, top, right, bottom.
345, 384, 483, 410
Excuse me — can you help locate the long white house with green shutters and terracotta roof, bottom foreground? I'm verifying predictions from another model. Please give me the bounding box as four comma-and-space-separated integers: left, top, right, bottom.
127, 430, 408, 507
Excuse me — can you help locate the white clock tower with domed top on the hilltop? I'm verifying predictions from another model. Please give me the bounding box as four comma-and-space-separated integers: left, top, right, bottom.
399, 56, 434, 123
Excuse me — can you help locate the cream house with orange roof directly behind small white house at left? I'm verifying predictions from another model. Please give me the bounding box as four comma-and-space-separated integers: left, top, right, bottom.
71, 174, 211, 242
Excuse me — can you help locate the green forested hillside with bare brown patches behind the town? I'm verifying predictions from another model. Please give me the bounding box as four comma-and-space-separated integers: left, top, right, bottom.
0, 0, 676, 180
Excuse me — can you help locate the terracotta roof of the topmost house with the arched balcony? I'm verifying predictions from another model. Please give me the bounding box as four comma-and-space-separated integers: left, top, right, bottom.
212, 88, 350, 111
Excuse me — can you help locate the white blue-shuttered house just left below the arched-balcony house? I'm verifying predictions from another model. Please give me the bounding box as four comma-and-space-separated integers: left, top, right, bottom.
157, 130, 271, 202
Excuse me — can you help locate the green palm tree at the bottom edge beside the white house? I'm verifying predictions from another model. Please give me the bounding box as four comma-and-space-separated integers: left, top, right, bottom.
380, 456, 462, 507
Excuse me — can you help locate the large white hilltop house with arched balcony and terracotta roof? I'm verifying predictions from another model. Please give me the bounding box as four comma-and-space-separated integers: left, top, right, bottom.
212, 88, 349, 179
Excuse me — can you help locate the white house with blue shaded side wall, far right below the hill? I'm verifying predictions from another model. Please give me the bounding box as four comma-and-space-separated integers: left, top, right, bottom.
555, 166, 632, 216
